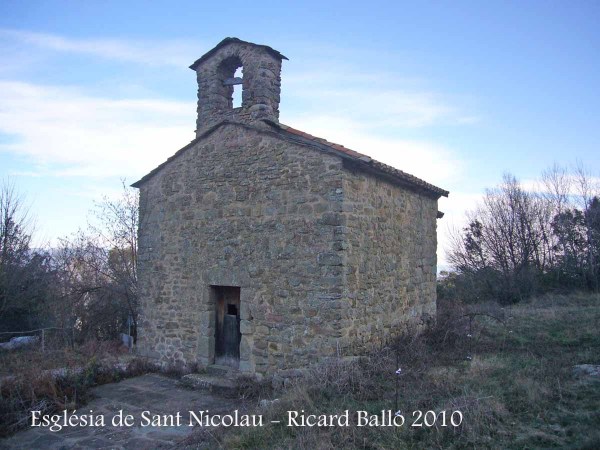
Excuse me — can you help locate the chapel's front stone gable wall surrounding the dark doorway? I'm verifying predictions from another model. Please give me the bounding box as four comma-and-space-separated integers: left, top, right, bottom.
139, 124, 343, 374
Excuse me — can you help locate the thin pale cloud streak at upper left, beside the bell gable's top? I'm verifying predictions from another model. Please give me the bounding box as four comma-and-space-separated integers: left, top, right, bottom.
0, 29, 204, 68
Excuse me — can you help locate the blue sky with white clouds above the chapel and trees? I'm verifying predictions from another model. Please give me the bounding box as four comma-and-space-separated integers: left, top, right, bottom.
0, 0, 600, 263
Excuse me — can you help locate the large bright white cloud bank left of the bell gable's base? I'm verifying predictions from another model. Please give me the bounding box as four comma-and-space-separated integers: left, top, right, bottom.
0, 81, 194, 178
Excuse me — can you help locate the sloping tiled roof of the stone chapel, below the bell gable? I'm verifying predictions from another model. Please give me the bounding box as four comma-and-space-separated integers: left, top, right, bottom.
131, 120, 449, 198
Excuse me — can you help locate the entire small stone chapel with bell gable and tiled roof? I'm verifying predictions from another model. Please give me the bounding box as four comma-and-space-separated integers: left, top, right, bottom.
133, 38, 448, 377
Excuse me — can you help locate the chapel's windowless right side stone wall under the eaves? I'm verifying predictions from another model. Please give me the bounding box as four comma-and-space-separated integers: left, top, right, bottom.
343, 162, 437, 351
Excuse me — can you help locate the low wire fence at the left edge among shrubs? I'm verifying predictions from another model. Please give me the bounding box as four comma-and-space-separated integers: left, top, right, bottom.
0, 327, 75, 352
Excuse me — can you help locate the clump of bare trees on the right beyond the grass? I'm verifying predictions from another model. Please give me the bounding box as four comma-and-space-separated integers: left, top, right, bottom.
449, 164, 600, 301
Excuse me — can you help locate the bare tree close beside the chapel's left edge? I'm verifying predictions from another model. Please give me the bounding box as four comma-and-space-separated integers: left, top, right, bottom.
60, 183, 139, 338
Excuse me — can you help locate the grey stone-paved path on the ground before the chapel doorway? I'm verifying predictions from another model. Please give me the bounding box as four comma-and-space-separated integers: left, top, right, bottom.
0, 374, 242, 450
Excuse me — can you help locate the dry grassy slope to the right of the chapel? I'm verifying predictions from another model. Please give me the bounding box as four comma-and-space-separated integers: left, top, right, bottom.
185, 295, 600, 449
